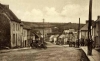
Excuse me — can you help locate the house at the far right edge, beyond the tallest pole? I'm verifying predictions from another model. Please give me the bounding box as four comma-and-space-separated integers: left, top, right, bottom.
92, 16, 100, 47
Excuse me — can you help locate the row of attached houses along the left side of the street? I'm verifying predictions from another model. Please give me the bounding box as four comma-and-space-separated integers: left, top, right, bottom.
0, 4, 31, 48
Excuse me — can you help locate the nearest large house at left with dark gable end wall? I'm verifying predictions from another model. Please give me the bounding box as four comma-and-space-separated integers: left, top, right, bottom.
0, 4, 21, 48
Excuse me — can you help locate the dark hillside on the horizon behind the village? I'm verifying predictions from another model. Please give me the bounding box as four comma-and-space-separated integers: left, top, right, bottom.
23, 22, 85, 31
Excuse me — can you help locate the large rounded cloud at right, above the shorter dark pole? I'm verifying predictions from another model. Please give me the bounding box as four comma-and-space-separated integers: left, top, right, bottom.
61, 4, 88, 23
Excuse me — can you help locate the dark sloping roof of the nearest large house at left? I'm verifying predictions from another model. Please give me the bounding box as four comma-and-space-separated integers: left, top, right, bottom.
0, 3, 21, 23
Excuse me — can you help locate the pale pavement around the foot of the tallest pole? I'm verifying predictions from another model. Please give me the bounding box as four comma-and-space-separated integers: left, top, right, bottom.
80, 46, 100, 61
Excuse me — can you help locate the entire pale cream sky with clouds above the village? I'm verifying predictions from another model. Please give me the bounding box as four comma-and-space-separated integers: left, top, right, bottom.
0, 0, 100, 23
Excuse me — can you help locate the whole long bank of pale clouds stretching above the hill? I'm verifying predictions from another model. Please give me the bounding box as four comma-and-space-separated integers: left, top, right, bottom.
11, 4, 88, 23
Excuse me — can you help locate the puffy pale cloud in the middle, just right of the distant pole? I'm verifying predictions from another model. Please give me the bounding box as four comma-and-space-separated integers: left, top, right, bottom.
44, 7, 62, 22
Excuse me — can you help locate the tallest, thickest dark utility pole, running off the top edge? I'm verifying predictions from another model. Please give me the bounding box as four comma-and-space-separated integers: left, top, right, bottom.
87, 0, 92, 55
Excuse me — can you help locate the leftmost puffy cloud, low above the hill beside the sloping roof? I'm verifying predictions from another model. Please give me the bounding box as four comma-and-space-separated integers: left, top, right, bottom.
16, 9, 43, 22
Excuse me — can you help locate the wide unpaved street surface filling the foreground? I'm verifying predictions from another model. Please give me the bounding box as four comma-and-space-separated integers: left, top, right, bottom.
0, 43, 89, 61
